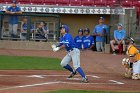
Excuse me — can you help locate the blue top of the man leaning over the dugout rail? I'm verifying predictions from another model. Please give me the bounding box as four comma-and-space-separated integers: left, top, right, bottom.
7, 6, 21, 24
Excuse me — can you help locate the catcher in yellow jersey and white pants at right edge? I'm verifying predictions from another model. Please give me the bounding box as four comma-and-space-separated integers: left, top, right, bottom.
127, 38, 140, 79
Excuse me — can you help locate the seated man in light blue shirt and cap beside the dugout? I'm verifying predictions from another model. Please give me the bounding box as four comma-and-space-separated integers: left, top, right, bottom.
110, 23, 126, 55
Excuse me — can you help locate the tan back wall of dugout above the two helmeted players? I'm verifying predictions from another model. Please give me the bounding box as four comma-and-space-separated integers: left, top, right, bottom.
60, 14, 110, 37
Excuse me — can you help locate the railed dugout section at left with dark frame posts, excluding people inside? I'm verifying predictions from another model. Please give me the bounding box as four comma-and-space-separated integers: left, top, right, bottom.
0, 12, 60, 41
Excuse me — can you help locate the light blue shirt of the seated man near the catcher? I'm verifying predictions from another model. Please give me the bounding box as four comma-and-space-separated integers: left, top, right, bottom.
114, 30, 126, 40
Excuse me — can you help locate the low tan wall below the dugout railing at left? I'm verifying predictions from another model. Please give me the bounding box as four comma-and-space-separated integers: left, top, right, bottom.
0, 40, 57, 50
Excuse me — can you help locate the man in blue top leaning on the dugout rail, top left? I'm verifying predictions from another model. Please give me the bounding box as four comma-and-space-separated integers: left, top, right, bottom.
5, 0, 22, 38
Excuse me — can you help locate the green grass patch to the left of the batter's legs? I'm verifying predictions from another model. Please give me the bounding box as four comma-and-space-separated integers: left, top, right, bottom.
0, 56, 63, 70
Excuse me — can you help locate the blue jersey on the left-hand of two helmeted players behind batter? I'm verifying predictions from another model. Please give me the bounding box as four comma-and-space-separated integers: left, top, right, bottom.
74, 36, 84, 49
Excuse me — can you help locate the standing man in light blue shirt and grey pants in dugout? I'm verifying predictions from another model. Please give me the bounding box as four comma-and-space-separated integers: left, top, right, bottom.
92, 17, 108, 52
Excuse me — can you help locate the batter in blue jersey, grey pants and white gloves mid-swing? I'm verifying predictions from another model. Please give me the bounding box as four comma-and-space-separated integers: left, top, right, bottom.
52, 25, 88, 83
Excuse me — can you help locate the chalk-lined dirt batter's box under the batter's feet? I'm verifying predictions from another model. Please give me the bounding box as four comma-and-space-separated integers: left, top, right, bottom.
27, 75, 124, 84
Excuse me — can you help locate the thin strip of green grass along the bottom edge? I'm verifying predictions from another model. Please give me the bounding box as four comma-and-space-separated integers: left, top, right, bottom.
45, 90, 139, 93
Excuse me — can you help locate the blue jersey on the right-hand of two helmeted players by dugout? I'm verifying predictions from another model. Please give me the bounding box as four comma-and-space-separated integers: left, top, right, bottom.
83, 36, 94, 49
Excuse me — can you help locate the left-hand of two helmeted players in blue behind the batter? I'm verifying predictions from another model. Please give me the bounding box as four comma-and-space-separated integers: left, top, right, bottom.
74, 28, 84, 50
